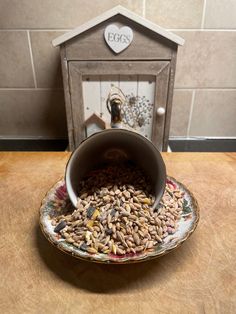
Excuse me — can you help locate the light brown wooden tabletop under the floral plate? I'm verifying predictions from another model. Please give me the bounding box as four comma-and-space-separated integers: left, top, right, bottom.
0, 152, 236, 314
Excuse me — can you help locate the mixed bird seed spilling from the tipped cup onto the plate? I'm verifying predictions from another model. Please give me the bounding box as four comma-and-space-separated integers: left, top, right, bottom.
51, 164, 183, 256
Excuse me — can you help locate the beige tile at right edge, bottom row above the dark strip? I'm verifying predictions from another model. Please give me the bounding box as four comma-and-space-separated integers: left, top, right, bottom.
190, 90, 236, 137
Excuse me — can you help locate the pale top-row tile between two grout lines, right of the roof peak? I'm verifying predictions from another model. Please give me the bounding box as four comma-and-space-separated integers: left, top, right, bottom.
146, 0, 204, 28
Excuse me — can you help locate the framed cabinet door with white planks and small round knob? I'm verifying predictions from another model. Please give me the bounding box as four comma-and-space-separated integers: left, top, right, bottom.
69, 61, 170, 150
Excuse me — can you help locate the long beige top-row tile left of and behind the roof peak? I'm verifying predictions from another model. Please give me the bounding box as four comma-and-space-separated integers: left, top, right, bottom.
0, 0, 142, 29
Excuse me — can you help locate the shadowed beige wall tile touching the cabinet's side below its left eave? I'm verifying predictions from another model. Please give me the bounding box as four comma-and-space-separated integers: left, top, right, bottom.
30, 31, 63, 87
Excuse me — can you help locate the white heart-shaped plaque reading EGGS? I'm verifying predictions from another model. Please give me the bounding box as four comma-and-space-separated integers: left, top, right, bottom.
104, 24, 134, 53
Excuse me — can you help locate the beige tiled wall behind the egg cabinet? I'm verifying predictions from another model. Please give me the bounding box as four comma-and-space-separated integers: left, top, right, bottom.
0, 0, 236, 138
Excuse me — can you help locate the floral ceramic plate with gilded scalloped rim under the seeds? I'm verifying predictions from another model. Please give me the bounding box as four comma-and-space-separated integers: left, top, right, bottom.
40, 177, 199, 264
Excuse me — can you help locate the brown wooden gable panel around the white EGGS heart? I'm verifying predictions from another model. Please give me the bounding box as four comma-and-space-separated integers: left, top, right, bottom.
65, 15, 173, 61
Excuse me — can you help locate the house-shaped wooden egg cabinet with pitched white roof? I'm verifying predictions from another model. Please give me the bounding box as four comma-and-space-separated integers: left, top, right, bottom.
53, 6, 184, 151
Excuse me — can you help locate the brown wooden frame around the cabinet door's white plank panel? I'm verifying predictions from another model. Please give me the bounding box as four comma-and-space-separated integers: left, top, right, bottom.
69, 61, 170, 150
